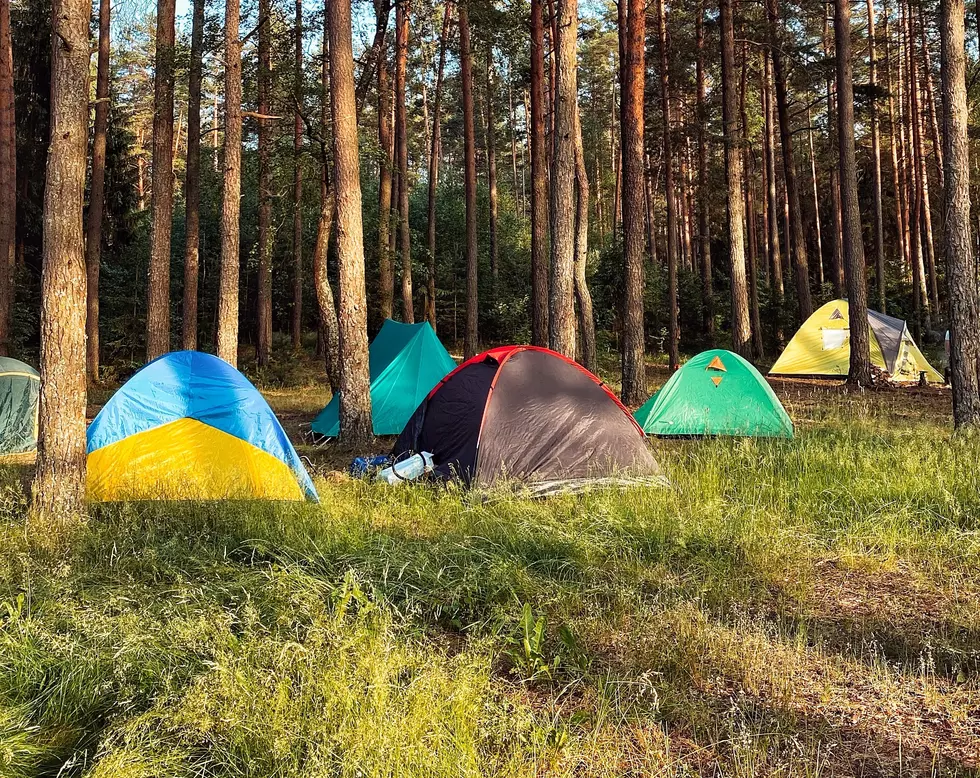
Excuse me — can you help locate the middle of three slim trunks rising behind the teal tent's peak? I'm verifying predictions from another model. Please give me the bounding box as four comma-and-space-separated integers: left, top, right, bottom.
395, 0, 415, 324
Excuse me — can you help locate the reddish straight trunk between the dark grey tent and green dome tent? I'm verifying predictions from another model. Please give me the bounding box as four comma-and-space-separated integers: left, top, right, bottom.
619, 0, 648, 398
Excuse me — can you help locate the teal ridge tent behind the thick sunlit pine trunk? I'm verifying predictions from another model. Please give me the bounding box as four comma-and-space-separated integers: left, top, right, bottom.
312, 319, 456, 438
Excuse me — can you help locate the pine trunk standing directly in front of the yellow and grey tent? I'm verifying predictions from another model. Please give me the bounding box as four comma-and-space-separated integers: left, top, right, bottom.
834, 0, 871, 386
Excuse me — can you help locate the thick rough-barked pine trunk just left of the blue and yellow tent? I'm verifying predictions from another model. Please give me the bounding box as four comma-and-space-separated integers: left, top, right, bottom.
32, 0, 92, 522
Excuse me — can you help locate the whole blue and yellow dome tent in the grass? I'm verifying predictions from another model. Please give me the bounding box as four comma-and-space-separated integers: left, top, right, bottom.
88, 351, 317, 502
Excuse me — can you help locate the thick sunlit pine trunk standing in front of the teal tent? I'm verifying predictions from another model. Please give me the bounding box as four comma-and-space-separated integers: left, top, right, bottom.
326, 0, 376, 445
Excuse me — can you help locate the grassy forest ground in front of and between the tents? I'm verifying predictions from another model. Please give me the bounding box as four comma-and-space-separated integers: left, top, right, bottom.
0, 360, 980, 778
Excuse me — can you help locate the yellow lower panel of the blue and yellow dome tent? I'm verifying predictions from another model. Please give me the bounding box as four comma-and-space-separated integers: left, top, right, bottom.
88, 418, 303, 502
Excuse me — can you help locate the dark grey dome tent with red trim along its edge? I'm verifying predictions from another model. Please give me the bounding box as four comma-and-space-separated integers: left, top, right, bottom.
393, 346, 660, 487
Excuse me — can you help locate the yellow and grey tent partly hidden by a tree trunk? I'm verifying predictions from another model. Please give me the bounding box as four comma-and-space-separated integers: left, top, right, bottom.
769, 300, 943, 383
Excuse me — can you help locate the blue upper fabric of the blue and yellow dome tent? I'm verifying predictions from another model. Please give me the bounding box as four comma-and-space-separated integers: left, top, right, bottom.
86, 351, 318, 500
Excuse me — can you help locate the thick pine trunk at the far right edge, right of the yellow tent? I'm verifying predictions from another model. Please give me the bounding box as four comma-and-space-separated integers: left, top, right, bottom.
940, 0, 980, 428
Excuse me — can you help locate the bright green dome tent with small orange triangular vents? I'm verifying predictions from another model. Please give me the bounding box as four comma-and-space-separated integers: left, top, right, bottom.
634, 349, 793, 438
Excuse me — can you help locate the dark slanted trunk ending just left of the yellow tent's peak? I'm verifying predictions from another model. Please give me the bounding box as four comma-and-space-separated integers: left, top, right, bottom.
767, 0, 813, 321
